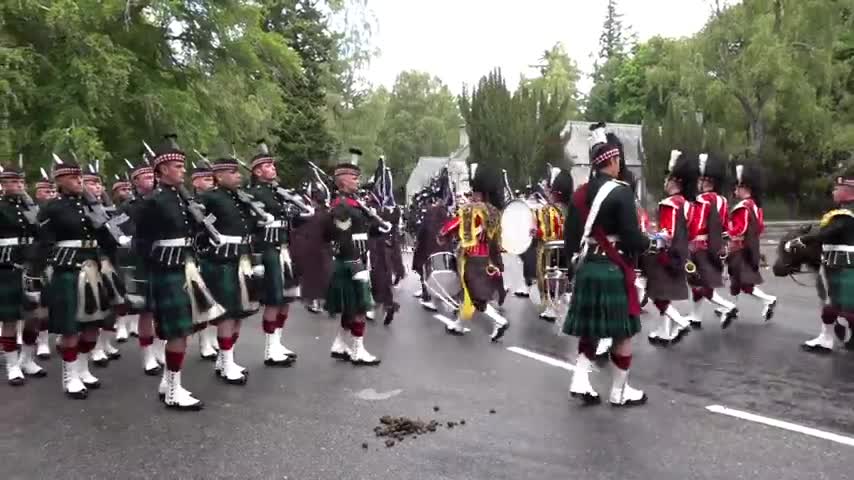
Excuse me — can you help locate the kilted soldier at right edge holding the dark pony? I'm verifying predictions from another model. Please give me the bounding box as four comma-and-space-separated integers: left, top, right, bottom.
783, 166, 854, 352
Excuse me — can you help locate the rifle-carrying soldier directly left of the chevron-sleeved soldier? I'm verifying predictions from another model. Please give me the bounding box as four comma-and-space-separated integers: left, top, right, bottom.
246, 141, 300, 366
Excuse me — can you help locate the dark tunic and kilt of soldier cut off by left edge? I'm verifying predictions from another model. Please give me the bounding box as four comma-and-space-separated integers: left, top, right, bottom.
0, 195, 38, 323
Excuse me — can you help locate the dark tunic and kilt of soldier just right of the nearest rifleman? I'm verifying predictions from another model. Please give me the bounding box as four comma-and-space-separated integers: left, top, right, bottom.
199, 187, 261, 319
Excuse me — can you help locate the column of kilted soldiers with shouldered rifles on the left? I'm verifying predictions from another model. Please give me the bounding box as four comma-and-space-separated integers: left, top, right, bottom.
0, 135, 404, 410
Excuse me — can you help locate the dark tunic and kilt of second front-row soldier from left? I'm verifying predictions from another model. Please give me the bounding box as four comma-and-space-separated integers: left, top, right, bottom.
39, 194, 109, 335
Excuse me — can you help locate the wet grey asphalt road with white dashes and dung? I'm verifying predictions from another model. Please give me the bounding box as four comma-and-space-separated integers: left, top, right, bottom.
0, 251, 854, 480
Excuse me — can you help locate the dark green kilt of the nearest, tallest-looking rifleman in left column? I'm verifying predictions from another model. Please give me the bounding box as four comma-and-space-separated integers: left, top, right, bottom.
146, 267, 199, 340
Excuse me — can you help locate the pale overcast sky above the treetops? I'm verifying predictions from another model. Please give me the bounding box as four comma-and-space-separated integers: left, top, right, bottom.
366, 0, 710, 93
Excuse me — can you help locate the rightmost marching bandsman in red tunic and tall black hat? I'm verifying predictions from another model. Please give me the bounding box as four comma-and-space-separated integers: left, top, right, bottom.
720, 164, 777, 328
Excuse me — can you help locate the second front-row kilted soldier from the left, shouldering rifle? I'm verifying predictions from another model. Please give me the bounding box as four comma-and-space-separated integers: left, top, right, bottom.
39, 157, 109, 399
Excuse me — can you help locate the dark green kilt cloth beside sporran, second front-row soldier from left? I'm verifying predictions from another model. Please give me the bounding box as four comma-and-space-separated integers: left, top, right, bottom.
42, 268, 108, 335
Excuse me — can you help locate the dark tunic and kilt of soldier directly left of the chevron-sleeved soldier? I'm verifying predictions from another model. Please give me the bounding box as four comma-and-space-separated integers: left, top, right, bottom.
246, 182, 300, 305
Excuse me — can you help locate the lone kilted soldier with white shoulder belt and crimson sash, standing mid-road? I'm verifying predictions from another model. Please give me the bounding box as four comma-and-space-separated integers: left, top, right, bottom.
563, 124, 649, 406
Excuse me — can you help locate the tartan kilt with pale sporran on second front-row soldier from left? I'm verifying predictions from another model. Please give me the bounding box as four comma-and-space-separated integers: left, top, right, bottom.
42, 260, 109, 335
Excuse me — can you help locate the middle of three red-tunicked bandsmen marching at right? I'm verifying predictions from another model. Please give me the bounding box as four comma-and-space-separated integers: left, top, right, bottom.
688, 153, 737, 327
